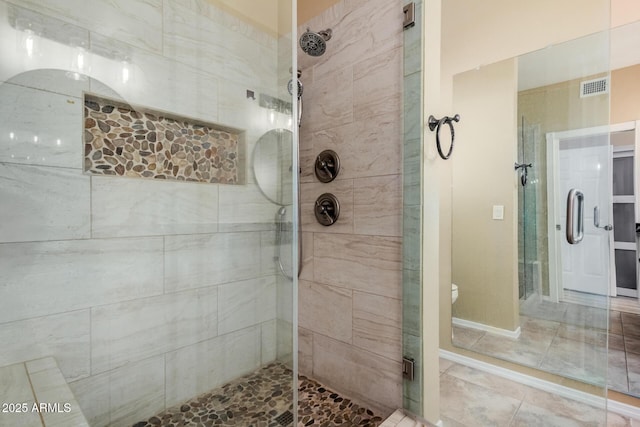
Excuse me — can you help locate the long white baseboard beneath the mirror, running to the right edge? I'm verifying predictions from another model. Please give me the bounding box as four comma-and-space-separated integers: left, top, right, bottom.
440, 349, 640, 419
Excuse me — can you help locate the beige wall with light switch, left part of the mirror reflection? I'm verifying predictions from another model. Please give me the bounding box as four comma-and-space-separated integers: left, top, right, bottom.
444, 59, 519, 331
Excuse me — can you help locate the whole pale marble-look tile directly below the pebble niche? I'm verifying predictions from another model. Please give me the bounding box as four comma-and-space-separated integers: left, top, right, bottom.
91, 177, 218, 237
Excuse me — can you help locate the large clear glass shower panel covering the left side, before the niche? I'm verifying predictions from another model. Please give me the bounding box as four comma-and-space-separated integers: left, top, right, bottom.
0, 0, 297, 426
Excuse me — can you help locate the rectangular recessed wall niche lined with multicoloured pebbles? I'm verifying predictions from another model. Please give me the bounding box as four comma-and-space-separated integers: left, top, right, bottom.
84, 95, 239, 184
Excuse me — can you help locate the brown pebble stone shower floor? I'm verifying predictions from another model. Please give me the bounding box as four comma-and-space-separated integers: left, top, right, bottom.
133, 363, 383, 427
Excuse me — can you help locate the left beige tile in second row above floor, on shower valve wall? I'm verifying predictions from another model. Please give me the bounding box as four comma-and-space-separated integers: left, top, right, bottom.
298, 280, 353, 343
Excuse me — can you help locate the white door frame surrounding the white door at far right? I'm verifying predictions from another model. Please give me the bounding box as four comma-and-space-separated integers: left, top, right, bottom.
546, 121, 640, 302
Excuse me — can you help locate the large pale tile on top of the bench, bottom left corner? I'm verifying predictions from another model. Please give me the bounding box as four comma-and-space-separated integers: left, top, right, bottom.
0, 363, 42, 427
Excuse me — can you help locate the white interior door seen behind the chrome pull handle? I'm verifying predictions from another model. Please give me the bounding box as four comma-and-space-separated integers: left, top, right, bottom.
555, 134, 612, 299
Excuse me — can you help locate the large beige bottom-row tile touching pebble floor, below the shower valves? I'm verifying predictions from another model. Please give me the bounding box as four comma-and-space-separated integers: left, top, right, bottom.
313, 334, 402, 412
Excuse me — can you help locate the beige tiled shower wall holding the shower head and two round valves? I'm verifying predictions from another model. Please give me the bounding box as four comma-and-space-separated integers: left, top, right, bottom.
298, 0, 403, 413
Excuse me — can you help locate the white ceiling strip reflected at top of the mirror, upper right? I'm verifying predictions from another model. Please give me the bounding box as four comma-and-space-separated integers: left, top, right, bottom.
518, 22, 640, 90
